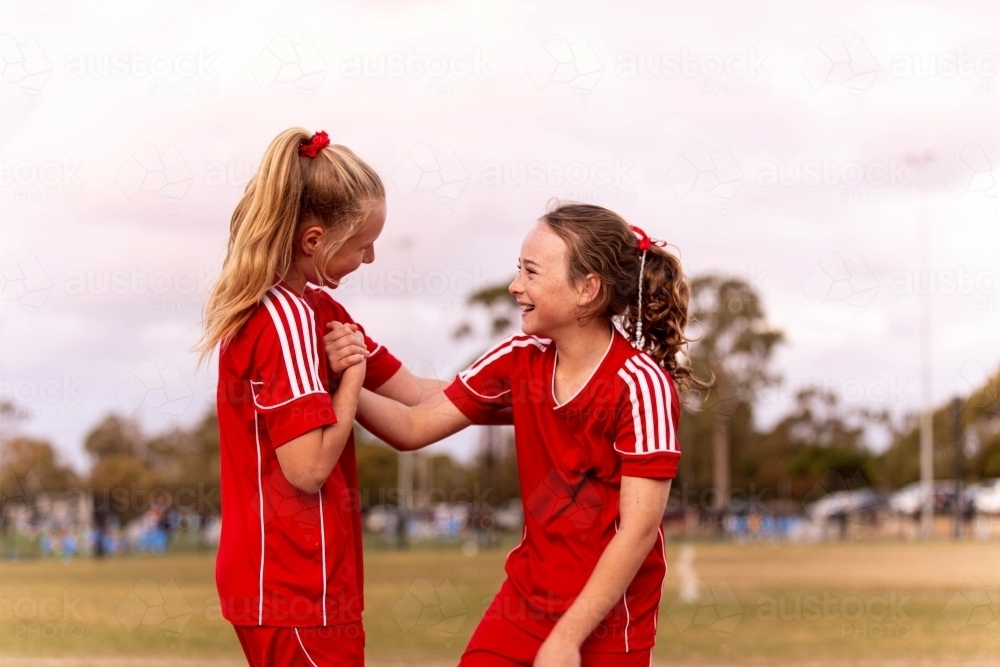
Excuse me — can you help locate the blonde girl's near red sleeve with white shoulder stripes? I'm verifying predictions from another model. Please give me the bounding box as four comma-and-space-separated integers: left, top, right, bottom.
250, 288, 337, 447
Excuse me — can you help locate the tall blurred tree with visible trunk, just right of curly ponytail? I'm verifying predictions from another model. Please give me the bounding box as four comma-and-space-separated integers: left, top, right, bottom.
690, 274, 784, 510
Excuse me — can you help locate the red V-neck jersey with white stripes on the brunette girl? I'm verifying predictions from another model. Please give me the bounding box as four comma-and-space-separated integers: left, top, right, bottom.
445, 331, 680, 653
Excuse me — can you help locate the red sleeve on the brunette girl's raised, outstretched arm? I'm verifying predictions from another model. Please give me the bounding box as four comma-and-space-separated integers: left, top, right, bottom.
444, 336, 524, 424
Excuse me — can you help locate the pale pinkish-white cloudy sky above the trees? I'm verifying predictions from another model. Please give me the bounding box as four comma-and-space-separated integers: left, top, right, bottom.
0, 1, 1000, 468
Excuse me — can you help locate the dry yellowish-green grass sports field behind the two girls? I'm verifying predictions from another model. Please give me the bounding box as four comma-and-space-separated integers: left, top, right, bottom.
0, 541, 1000, 667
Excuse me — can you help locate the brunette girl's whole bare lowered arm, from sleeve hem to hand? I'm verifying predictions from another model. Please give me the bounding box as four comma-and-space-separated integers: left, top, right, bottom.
534, 476, 671, 667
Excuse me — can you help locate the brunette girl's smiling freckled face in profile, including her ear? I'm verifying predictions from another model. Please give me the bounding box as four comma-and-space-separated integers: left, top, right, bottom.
508, 220, 599, 338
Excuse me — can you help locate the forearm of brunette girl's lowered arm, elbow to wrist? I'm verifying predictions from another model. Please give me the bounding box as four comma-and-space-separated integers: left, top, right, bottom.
550, 525, 659, 648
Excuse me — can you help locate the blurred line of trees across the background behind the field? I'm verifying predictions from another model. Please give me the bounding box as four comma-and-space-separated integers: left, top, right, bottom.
0, 274, 1000, 522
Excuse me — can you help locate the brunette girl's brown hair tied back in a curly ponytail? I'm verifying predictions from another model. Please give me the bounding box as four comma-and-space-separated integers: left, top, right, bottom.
542, 203, 709, 393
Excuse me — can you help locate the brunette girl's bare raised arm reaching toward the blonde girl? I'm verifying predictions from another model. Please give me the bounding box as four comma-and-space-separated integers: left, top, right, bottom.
358, 389, 472, 451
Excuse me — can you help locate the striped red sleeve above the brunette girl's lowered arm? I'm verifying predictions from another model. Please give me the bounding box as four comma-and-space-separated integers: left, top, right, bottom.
615, 354, 681, 479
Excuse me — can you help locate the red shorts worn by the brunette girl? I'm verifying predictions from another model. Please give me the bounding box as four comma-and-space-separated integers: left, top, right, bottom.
458, 582, 653, 667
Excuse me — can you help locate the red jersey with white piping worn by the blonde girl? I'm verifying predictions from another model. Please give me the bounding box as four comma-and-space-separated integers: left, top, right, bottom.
215, 282, 400, 627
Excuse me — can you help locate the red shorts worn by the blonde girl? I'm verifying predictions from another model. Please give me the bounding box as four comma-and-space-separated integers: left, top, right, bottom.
233, 621, 365, 667
